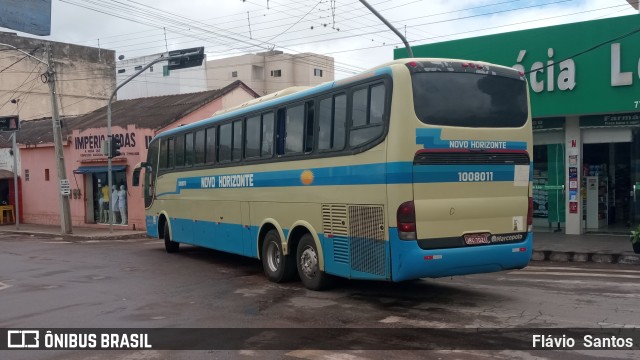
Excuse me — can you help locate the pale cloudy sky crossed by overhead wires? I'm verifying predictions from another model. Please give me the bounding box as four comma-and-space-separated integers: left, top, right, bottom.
0, 0, 638, 79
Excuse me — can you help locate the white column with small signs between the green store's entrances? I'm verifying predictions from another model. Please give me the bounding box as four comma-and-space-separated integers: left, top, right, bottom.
564, 116, 583, 235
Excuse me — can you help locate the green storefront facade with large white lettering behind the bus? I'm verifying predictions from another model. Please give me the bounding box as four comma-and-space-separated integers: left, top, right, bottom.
395, 15, 640, 234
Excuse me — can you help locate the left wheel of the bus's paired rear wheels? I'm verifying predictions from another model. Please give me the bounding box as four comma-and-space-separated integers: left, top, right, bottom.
262, 230, 296, 283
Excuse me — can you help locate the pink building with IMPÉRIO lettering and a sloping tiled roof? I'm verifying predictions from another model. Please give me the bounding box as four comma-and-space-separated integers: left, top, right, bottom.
18, 81, 258, 229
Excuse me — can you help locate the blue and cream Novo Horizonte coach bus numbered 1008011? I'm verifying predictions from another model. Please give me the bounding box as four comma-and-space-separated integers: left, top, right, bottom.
134, 59, 532, 289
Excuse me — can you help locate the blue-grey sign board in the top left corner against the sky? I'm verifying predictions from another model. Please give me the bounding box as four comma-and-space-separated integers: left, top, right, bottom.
0, 0, 51, 36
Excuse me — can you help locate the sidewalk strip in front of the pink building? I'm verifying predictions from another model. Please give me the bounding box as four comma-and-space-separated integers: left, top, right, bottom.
0, 224, 147, 240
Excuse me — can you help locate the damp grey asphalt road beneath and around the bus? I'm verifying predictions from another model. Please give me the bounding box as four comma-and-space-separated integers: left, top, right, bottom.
0, 234, 640, 360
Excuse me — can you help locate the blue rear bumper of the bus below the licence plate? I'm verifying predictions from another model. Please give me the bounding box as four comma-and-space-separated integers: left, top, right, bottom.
390, 229, 533, 281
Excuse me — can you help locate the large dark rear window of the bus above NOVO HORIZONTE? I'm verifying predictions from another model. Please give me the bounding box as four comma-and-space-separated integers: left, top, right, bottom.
411, 72, 529, 128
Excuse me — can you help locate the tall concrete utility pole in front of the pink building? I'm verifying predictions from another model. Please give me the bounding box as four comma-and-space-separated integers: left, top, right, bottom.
47, 44, 72, 234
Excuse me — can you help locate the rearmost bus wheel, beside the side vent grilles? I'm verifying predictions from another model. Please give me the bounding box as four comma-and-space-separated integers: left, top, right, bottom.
296, 234, 333, 290
